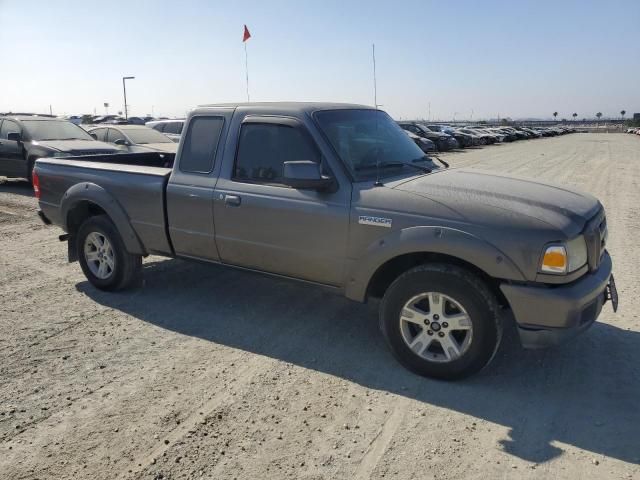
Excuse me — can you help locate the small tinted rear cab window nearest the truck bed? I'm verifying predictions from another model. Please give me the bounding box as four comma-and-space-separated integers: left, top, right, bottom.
179, 117, 224, 173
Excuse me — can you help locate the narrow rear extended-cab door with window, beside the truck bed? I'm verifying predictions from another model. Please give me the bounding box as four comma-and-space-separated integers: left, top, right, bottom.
167, 110, 233, 261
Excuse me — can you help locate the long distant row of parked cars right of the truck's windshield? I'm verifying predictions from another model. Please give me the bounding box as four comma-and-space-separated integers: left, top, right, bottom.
398, 122, 575, 153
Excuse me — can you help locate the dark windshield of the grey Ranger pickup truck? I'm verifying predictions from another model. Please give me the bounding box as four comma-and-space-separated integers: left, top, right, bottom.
315, 110, 431, 181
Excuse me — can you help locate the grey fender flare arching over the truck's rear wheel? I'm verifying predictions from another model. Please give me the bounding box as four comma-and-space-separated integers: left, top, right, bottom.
60, 182, 147, 255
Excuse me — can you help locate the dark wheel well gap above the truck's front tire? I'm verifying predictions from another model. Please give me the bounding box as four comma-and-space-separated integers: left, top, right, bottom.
367, 252, 509, 307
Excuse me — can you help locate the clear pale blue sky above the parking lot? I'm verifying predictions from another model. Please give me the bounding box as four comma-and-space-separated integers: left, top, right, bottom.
0, 0, 640, 119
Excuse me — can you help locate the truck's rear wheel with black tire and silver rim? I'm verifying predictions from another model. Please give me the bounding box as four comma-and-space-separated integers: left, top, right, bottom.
76, 215, 142, 291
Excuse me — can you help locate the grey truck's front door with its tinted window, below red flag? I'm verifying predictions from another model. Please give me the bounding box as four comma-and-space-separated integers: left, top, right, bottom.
214, 114, 351, 286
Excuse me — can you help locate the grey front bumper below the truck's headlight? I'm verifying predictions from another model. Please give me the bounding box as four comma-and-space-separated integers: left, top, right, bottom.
500, 252, 613, 348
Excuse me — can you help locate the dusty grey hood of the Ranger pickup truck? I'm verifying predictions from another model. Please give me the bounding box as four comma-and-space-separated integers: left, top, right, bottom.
388, 169, 602, 238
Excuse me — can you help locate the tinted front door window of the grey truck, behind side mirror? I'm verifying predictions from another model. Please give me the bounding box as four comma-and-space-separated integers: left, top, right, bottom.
234, 123, 321, 185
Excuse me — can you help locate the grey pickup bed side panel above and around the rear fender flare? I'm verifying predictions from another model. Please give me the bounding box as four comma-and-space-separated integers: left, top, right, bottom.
35, 153, 173, 254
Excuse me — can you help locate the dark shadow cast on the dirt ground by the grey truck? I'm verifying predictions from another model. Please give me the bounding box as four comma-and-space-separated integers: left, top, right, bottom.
77, 260, 640, 463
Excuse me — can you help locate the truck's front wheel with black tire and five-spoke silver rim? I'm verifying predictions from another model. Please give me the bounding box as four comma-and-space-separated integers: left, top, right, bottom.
380, 264, 502, 380
